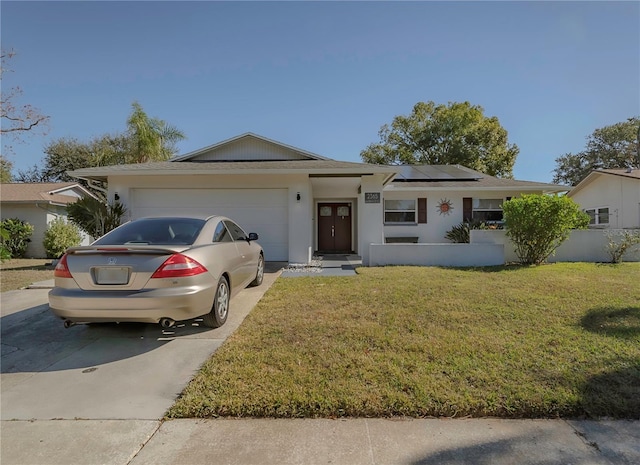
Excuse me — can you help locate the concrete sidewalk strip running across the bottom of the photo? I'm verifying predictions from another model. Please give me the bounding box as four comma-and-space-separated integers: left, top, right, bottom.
1, 419, 640, 465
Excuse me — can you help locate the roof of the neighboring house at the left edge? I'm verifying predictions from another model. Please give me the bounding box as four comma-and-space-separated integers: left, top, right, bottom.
0, 182, 90, 205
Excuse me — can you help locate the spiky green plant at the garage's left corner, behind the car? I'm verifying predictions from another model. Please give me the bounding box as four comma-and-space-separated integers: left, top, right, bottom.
67, 197, 126, 239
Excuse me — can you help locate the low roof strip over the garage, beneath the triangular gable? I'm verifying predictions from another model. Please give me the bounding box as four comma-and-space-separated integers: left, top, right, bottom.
69, 159, 398, 181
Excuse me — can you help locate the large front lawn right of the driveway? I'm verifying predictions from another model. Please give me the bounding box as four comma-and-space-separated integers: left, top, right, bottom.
167, 263, 640, 419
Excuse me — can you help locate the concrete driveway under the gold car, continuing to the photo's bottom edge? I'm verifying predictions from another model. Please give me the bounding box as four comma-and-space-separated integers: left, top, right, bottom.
0, 263, 282, 465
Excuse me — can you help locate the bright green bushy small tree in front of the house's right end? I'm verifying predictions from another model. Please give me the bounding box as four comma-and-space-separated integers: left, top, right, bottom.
502, 194, 589, 265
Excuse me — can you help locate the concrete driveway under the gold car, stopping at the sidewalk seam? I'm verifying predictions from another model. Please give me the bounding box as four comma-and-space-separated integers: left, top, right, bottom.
0, 265, 280, 421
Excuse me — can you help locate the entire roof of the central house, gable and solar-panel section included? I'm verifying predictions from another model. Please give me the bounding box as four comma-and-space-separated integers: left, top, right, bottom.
69, 133, 569, 192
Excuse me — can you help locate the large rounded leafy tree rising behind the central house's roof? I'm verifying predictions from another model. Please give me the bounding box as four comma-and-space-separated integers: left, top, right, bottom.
360, 102, 519, 178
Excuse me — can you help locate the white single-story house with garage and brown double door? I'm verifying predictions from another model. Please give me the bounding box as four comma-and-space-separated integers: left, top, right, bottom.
70, 133, 567, 264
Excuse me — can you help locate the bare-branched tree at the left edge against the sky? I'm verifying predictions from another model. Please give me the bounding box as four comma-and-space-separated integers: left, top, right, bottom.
0, 50, 49, 155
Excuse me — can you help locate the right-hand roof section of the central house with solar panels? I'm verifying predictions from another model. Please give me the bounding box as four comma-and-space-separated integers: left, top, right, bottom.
388, 165, 569, 193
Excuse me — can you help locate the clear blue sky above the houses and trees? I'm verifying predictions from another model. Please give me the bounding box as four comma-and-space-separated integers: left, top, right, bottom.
0, 1, 640, 182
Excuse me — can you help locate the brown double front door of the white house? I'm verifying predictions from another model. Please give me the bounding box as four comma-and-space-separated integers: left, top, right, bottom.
318, 203, 352, 253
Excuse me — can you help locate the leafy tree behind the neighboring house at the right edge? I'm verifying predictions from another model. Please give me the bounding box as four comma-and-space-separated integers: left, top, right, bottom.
553, 117, 640, 186
